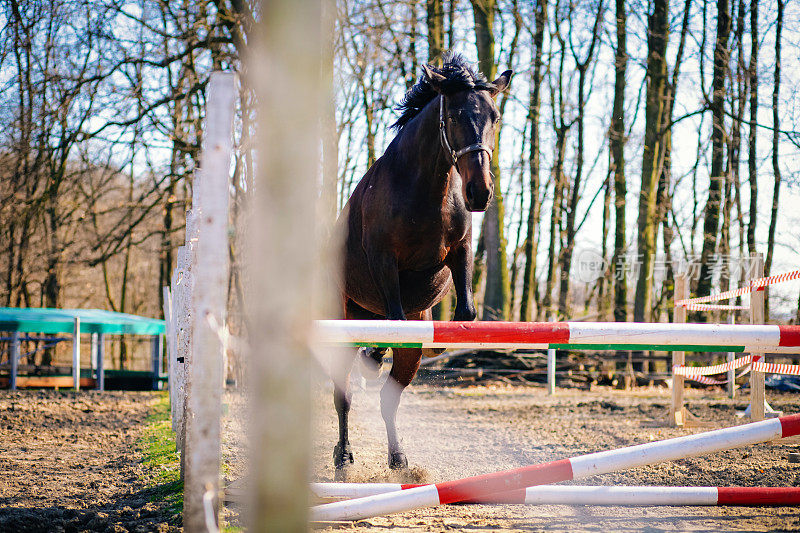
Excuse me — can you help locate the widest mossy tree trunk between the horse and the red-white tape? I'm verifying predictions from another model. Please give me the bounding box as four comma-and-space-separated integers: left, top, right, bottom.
633, 0, 669, 322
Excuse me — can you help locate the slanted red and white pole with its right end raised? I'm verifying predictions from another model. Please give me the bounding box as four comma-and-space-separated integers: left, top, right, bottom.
311, 414, 800, 521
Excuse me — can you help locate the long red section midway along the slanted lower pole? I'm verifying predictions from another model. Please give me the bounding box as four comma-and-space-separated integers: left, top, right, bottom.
436, 459, 572, 504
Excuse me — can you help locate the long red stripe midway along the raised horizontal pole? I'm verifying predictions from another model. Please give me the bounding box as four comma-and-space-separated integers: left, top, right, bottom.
433, 322, 569, 344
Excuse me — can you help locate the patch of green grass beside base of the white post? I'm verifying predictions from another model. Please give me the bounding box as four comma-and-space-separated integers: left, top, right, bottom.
138, 392, 183, 515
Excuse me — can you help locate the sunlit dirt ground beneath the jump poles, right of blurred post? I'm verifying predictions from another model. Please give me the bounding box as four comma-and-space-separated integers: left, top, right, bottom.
314, 385, 800, 531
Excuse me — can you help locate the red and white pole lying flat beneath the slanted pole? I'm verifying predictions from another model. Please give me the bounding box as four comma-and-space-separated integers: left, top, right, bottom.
311, 483, 800, 506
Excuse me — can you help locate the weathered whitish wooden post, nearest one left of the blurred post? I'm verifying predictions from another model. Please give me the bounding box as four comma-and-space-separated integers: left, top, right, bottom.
183, 72, 238, 531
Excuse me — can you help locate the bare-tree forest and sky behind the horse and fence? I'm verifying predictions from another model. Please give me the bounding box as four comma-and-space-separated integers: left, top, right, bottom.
0, 0, 800, 366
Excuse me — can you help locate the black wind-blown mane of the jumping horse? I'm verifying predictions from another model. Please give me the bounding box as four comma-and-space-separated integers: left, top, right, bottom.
392, 52, 495, 130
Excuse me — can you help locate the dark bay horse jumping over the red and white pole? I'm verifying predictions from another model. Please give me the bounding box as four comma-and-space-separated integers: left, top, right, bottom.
333, 55, 513, 470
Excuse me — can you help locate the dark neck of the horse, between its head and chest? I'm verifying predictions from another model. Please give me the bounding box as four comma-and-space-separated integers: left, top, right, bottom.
398, 99, 452, 202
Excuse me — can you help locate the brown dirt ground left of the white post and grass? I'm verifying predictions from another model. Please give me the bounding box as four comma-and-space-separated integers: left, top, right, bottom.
0, 390, 176, 533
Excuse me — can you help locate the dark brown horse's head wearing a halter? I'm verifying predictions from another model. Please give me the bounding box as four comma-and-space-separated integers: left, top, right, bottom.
423, 66, 513, 211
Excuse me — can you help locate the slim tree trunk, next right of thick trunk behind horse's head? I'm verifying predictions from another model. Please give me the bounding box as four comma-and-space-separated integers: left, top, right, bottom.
519, 0, 548, 321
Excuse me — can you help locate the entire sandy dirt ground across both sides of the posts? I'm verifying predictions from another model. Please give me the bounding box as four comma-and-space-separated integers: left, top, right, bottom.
0, 385, 800, 532
